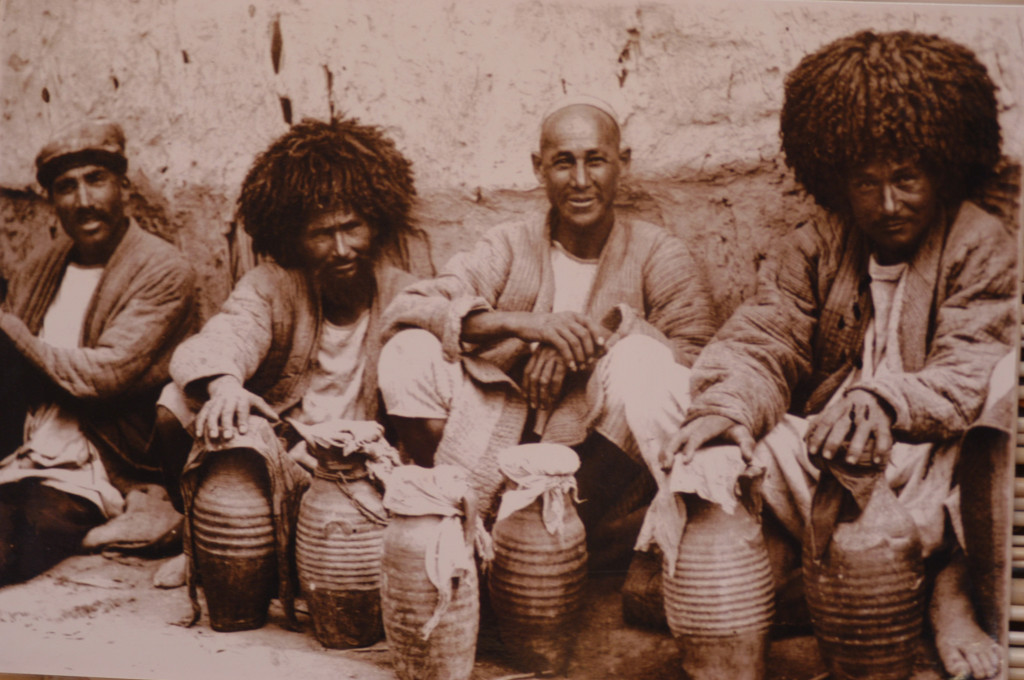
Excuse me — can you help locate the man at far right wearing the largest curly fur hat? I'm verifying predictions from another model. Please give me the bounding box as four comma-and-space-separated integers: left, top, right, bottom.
633, 32, 1017, 678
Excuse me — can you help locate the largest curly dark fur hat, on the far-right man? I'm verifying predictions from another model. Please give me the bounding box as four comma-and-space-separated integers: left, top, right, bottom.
780, 31, 1000, 211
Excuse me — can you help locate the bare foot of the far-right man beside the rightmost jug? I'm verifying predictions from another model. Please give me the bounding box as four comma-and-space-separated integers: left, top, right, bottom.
929, 550, 1002, 680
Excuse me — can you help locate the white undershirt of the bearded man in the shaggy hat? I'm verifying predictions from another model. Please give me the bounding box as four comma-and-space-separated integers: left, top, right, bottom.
295, 311, 370, 425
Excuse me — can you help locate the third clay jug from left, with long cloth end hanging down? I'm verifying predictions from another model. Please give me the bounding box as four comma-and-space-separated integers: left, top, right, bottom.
381, 465, 480, 680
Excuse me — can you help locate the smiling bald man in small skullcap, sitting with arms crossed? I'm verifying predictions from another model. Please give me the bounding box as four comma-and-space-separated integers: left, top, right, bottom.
380, 97, 714, 557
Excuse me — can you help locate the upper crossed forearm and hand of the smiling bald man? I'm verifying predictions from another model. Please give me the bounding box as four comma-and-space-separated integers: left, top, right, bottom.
462, 311, 610, 371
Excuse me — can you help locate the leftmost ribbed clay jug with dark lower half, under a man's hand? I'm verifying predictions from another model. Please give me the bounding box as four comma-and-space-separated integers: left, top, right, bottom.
191, 450, 278, 632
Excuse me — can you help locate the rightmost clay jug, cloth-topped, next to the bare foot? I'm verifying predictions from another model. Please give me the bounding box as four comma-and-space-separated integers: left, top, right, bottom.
803, 470, 925, 680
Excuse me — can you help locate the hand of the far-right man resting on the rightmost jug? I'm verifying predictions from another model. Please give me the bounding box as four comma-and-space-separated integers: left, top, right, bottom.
806, 389, 893, 466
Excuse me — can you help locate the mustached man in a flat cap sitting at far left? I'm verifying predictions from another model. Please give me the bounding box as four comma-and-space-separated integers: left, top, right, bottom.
0, 121, 195, 584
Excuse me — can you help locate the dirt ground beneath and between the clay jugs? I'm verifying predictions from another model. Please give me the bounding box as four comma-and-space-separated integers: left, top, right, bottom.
0, 555, 939, 680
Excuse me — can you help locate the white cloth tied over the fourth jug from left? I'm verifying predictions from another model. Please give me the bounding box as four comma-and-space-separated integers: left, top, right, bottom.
496, 443, 580, 535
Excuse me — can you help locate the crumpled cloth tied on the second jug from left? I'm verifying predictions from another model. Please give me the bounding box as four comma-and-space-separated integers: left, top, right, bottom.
286, 418, 401, 486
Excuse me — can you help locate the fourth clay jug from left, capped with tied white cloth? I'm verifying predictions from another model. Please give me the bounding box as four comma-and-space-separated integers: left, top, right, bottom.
488, 443, 587, 674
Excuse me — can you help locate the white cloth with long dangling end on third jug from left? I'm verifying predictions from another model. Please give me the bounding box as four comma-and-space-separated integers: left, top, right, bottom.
384, 465, 494, 640
